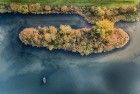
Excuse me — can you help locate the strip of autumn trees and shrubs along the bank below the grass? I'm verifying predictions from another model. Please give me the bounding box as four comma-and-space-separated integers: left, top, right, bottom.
0, 3, 140, 24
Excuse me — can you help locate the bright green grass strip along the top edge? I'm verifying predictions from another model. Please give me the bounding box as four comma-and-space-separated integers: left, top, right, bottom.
0, 0, 140, 6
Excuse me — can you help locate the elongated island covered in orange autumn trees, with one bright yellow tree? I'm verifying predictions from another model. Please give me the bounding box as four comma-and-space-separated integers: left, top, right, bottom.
19, 19, 129, 55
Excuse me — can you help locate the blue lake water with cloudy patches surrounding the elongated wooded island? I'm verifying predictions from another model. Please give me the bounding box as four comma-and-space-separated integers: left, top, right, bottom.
0, 14, 140, 94
